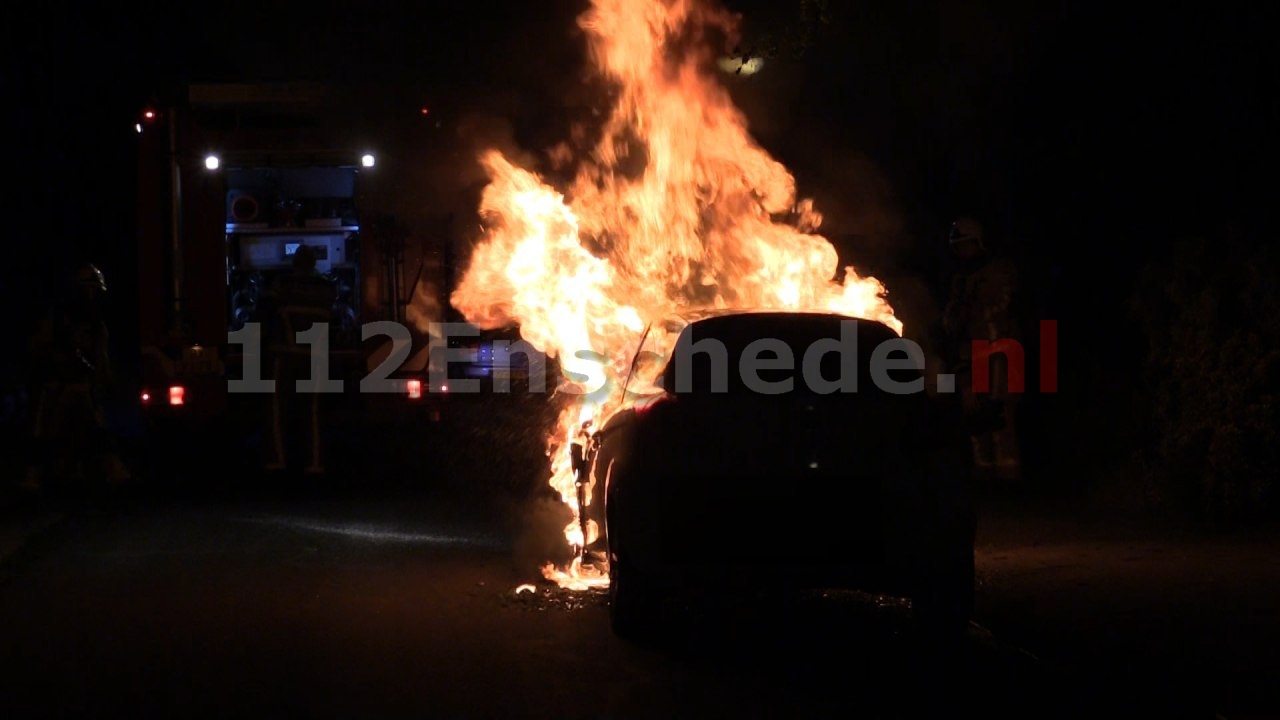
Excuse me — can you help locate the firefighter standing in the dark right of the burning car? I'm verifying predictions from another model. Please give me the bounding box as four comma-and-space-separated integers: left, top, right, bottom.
942, 217, 1023, 479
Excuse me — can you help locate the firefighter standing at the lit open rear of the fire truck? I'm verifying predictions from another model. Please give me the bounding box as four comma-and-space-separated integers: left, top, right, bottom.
264, 245, 338, 475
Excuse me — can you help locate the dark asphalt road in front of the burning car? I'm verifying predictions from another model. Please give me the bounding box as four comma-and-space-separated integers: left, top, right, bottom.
0, 474, 1239, 717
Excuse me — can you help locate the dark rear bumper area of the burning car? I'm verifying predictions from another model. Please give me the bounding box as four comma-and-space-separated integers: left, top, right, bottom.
607, 458, 973, 594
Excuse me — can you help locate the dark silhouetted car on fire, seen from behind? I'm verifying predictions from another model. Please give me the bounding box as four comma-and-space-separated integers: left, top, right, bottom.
579, 311, 975, 637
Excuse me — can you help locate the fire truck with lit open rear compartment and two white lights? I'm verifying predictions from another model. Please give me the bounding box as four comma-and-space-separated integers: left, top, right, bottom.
137, 83, 447, 461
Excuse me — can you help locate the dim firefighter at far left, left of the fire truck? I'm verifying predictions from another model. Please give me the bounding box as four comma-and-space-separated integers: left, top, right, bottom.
24, 265, 129, 491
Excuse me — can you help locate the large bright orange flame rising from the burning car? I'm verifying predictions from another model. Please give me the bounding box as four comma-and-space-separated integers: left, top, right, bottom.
452, 0, 902, 589
